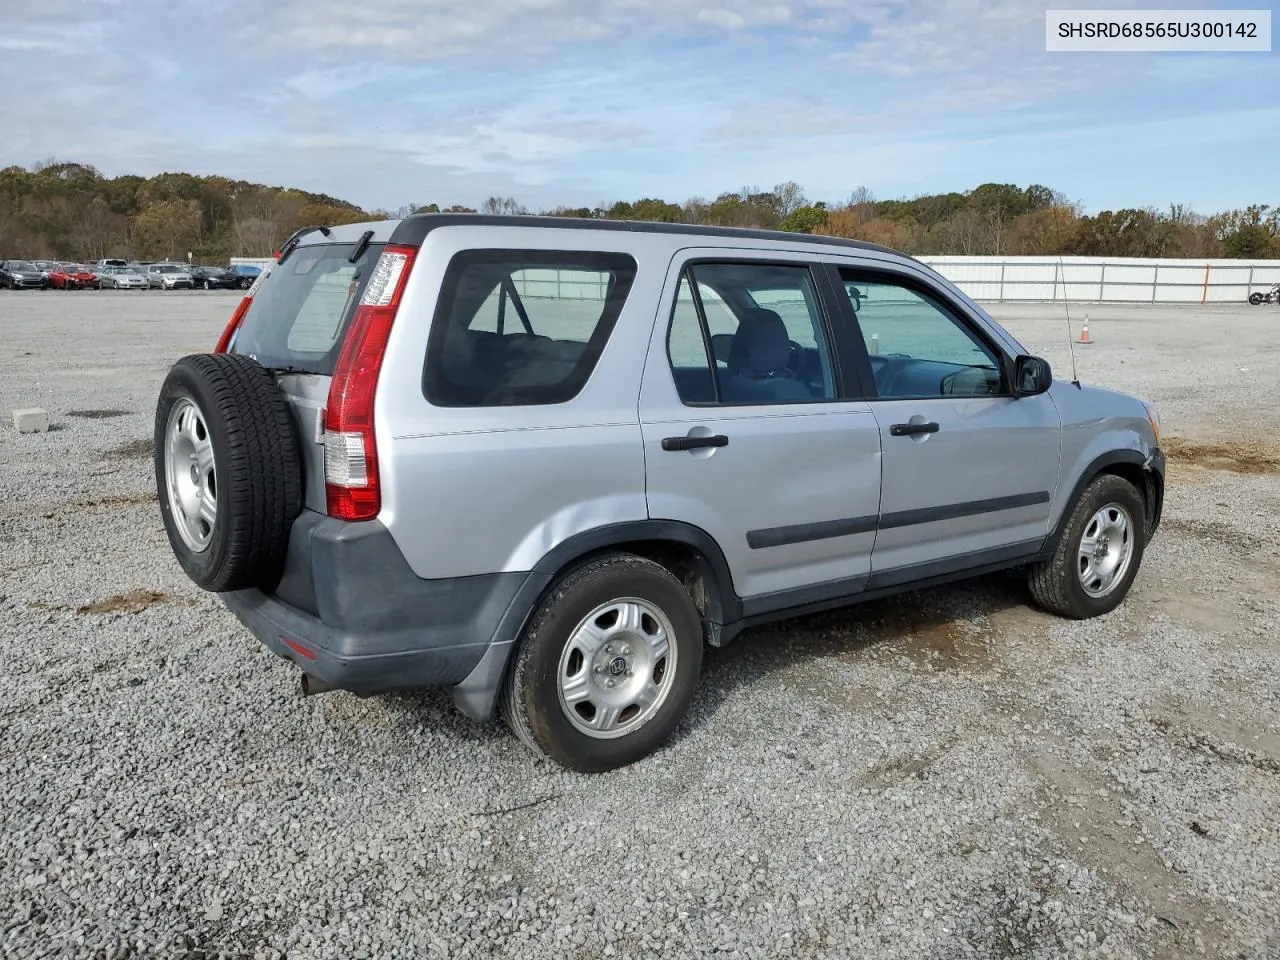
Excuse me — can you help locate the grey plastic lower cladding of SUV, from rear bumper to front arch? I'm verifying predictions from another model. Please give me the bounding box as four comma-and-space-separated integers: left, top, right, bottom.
221, 449, 1165, 721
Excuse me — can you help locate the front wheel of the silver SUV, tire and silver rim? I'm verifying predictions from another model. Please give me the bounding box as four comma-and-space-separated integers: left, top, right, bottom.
1027, 474, 1147, 620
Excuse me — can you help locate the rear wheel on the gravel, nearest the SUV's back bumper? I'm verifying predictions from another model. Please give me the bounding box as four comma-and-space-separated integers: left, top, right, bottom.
502, 553, 703, 773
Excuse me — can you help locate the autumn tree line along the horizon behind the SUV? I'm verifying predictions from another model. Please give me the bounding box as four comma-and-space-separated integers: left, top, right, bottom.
0, 163, 1280, 262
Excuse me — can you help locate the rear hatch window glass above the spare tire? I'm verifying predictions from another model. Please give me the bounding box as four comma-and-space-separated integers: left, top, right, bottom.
233, 243, 383, 376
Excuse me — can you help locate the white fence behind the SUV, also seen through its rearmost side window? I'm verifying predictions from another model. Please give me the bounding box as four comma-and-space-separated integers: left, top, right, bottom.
232, 256, 1280, 303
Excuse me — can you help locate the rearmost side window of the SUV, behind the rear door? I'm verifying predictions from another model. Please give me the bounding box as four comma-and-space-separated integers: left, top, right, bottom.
422, 250, 636, 407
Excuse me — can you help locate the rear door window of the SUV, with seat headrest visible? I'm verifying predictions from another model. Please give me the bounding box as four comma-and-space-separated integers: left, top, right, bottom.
667, 264, 836, 404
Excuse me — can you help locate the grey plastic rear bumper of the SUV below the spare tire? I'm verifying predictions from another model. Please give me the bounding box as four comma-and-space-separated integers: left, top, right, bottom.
221, 511, 543, 718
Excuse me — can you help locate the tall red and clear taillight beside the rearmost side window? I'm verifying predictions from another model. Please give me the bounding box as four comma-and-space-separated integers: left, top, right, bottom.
324, 246, 416, 520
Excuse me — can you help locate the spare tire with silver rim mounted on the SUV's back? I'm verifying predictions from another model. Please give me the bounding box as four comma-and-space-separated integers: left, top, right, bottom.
154, 353, 302, 591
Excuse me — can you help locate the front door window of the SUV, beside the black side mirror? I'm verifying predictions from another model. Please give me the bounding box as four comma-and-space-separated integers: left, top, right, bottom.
841, 271, 1004, 399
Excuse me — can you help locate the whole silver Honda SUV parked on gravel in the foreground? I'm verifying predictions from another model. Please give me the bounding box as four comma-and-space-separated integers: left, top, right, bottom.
155, 215, 1165, 771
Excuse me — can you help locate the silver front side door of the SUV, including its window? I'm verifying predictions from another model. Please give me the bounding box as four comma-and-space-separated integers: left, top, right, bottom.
840, 269, 1061, 589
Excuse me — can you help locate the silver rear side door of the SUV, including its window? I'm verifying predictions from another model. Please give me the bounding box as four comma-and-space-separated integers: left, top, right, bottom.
640, 248, 881, 604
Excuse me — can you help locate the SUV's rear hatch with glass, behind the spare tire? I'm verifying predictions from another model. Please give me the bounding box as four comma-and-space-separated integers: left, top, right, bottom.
230, 235, 385, 513
